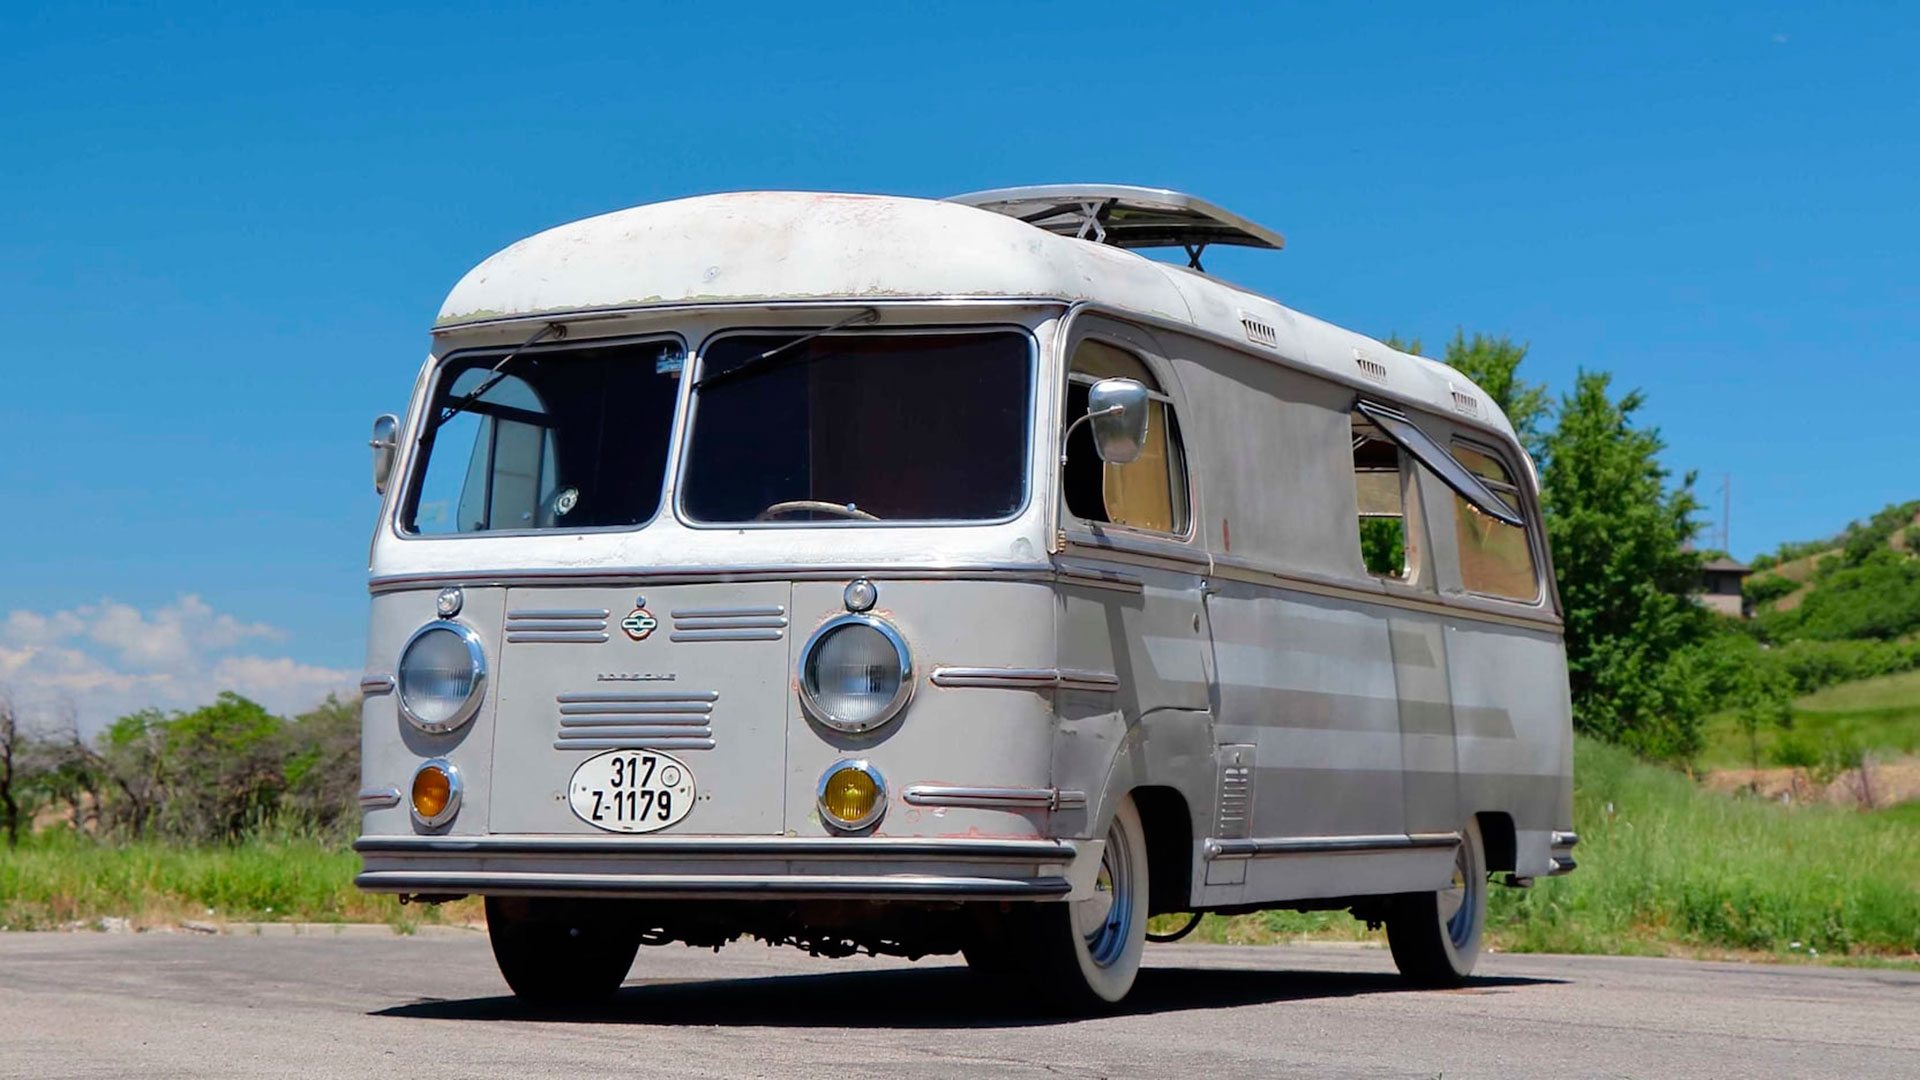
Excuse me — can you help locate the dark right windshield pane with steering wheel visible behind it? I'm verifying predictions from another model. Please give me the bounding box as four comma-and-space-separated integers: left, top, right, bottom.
682, 331, 1033, 523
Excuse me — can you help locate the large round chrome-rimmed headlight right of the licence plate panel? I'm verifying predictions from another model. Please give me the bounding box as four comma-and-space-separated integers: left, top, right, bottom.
801, 615, 914, 732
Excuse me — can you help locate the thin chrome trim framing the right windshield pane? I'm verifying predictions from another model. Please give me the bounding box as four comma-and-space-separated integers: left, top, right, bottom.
672, 322, 1041, 532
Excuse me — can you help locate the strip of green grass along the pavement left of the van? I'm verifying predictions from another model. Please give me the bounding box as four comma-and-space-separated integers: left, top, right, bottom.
0, 828, 478, 930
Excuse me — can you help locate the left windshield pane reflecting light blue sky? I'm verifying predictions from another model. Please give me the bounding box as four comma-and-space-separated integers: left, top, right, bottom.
401, 340, 684, 536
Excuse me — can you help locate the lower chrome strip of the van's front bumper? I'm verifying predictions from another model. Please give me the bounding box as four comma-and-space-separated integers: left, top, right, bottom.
353, 871, 1073, 899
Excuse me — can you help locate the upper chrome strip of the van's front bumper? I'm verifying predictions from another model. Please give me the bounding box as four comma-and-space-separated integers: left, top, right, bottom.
353, 834, 1079, 863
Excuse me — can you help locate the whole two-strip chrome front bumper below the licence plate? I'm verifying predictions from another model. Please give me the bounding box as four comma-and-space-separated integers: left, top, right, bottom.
353, 836, 1100, 901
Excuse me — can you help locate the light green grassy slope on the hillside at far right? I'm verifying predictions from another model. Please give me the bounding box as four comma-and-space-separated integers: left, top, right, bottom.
1699, 671, 1920, 769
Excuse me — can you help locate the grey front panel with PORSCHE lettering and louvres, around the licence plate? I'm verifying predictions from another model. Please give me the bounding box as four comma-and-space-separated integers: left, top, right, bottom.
490, 582, 793, 834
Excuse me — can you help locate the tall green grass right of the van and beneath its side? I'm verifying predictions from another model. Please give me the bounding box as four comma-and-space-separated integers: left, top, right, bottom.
1182, 738, 1920, 959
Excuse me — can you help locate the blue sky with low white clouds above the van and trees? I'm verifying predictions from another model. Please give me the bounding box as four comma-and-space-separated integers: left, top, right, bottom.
0, 2, 1920, 717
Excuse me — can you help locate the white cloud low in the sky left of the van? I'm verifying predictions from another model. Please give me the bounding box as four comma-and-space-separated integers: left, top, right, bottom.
0, 594, 355, 734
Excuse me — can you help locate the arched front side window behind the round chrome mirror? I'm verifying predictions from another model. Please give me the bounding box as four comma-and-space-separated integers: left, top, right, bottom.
1062, 340, 1188, 536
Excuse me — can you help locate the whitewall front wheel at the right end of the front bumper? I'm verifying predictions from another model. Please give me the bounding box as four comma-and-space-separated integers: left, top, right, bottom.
966, 796, 1148, 1013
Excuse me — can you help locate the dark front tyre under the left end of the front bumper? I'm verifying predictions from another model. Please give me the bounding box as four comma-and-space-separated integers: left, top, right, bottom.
486, 896, 639, 1005
